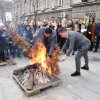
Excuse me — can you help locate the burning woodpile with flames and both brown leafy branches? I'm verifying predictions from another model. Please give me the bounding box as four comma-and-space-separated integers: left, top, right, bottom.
10, 28, 60, 90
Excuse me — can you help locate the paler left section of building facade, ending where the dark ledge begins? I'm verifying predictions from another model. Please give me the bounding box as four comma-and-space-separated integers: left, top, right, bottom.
13, 0, 72, 20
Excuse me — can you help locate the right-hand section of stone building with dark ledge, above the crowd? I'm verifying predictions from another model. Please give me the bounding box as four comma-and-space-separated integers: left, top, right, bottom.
71, 0, 100, 22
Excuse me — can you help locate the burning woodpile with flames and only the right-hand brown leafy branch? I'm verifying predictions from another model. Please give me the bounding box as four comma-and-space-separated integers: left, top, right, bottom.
13, 43, 60, 90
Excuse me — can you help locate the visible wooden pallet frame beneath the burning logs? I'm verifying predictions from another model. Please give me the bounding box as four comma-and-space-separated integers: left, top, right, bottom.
13, 75, 62, 97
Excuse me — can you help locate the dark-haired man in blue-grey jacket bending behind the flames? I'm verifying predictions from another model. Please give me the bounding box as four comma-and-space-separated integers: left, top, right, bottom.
36, 28, 57, 56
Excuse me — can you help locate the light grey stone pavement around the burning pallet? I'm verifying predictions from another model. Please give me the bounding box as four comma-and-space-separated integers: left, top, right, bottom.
0, 52, 100, 100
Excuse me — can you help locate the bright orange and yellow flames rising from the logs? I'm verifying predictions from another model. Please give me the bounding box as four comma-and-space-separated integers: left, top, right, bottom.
31, 43, 52, 75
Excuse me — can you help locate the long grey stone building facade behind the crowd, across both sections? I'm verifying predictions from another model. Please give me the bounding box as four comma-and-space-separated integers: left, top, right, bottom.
13, 0, 100, 20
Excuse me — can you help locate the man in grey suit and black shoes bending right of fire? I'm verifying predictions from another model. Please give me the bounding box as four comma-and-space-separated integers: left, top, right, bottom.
59, 28, 91, 76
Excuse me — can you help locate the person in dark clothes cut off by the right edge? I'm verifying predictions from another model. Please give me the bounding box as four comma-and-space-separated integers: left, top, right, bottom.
94, 23, 100, 52
